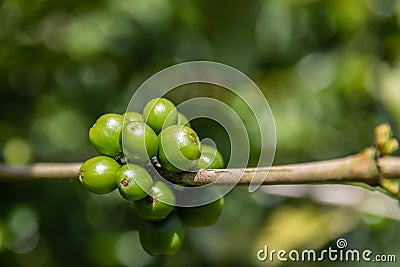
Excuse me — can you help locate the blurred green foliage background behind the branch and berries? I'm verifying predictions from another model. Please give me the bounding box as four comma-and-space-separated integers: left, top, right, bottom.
0, 0, 400, 266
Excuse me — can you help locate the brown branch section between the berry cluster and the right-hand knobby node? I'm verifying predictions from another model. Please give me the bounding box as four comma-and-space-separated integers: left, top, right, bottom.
162, 148, 378, 185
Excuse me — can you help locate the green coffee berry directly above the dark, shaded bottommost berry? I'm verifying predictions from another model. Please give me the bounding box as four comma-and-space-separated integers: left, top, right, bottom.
135, 181, 175, 221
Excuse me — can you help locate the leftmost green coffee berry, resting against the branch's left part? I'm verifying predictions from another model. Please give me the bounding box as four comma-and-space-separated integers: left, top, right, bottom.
79, 156, 120, 194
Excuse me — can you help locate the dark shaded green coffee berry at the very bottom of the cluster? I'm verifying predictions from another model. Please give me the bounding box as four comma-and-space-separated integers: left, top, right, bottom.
139, 212, 185, 256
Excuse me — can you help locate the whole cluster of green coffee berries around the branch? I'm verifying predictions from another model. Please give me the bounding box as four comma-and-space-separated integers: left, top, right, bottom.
79, 98, 224, 256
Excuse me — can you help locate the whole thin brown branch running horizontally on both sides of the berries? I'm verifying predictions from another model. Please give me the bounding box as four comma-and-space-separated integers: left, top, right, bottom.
0, 148, 400, 189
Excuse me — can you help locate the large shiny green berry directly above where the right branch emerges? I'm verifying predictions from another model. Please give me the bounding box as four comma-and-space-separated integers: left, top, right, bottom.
158, 125, 201, 172
